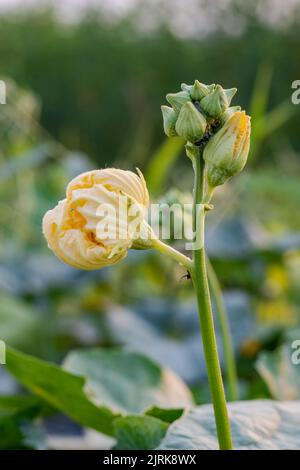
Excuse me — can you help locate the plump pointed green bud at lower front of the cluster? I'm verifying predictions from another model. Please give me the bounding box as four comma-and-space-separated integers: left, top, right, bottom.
175, 102, 206, 142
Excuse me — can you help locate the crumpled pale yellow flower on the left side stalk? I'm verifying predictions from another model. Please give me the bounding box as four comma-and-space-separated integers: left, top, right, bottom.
43, 168, 149, 270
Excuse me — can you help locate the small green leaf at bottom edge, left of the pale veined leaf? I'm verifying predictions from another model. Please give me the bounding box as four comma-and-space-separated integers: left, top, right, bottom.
114, 416, 169, 450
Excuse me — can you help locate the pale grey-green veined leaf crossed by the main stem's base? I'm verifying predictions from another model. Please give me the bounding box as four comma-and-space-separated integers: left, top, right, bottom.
158, 400, 300, 450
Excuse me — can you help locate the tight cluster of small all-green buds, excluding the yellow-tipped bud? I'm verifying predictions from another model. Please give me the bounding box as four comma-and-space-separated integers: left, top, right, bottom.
161, 80, 237, 143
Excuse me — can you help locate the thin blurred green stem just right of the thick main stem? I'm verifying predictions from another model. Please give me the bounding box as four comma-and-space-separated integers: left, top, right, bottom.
206, 257, 238, 401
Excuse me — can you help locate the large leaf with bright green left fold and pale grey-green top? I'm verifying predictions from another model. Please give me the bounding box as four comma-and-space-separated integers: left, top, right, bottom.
5, 348, 193, 436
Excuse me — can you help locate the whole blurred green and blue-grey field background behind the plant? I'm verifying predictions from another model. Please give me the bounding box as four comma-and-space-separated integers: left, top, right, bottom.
0, 0, 300, 448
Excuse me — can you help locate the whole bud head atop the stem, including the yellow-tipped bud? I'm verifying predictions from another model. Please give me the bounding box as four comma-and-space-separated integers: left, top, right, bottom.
161, 80, 251, 192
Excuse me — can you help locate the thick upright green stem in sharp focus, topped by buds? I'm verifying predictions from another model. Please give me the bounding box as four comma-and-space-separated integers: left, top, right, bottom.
192, 152, 232, 450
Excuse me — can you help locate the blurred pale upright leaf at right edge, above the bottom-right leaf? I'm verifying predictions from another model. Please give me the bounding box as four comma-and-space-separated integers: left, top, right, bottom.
256, 345, 300, 400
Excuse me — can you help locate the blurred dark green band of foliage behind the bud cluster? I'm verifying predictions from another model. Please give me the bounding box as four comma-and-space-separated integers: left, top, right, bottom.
0, 0, 300, 166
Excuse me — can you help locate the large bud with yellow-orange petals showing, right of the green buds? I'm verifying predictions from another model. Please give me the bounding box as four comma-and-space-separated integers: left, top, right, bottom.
203, 111, 251, 187
